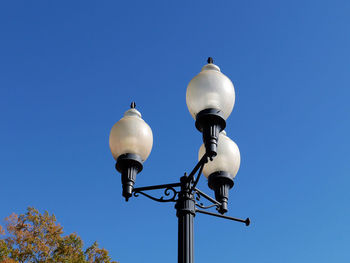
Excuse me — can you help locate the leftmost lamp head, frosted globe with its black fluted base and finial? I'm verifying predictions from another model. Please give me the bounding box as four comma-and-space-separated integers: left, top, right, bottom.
109, 102, 153, 201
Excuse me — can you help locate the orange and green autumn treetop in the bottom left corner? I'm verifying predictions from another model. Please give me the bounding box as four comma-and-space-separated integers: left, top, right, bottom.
0, 207, 116, 263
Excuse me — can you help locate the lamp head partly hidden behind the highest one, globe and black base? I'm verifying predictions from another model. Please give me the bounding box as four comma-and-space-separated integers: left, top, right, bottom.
198, 131, 241, 214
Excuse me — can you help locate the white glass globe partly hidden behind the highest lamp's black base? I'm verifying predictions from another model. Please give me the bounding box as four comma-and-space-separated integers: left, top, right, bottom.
198, 131, 241, 179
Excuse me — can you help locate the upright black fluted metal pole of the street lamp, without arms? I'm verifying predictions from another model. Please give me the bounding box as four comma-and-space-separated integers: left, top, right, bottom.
175, 176, 196, 263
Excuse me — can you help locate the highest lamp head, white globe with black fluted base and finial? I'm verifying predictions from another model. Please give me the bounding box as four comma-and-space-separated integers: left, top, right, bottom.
186, 58, 235, 158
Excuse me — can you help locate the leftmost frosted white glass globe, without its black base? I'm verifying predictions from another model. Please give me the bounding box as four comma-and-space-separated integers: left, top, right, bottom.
109, 108, 153, 161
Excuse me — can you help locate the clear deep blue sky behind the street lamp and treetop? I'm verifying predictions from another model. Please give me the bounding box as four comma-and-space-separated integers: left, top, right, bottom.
0, 1, 350, 263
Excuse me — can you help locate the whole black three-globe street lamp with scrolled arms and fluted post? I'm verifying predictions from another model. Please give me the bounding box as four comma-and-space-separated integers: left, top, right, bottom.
109, 58, 250, 263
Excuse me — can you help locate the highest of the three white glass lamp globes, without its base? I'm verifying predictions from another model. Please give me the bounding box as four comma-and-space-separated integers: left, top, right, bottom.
186, 63, 235, 120
